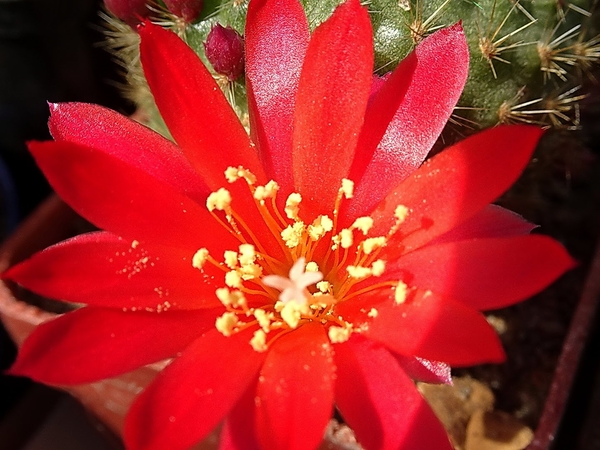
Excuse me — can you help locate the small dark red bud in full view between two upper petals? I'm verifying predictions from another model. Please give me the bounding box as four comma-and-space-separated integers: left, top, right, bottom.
204, 24, 244, 81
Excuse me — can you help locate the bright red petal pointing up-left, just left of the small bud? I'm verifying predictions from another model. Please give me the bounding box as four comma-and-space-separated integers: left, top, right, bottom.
139, 22, 264, 189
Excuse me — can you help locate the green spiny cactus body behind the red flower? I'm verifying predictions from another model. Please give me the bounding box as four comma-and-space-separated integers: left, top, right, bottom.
101, 0, 600, 138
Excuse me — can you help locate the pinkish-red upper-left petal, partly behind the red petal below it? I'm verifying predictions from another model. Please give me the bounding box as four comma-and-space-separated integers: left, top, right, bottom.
48, 103, 208, 201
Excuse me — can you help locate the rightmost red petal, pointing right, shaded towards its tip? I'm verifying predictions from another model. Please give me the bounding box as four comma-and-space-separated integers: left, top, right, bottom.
385, 235, 575, 310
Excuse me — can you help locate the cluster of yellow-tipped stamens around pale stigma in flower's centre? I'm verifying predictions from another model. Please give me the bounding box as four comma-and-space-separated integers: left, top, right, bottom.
192, 167, 409, 351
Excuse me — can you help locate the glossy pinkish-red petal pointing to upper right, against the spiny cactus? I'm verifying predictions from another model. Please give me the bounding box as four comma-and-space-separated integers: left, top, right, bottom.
349, 24, 469, 217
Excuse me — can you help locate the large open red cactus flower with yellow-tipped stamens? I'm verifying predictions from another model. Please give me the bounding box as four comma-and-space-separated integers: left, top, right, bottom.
5, 0, 573, 449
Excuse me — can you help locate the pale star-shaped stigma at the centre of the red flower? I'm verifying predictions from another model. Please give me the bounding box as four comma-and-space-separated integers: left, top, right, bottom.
262, 257, 323, 305
